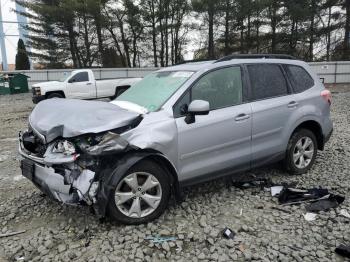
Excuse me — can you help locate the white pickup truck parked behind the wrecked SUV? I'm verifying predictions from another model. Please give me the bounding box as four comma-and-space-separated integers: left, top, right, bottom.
32, 69, 141, 104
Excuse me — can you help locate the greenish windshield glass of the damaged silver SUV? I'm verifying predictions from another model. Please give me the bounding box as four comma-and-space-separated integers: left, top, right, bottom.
116, 71, 193, 112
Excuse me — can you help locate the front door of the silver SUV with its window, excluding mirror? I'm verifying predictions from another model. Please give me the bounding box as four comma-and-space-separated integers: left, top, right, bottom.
174, 66, 251, 184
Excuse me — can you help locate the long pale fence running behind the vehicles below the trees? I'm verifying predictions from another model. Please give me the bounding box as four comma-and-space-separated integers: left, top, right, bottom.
2, 61, 350, 85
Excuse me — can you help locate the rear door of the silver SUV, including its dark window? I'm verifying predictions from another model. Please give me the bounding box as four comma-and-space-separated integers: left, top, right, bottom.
247, 64, 298, 167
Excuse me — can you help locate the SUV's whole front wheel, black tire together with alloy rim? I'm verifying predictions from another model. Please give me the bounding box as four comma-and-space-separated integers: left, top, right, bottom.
107, 160, 171, 225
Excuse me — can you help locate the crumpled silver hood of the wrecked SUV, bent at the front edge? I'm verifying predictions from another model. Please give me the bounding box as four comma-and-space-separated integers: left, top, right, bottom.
29, 98, 140, 143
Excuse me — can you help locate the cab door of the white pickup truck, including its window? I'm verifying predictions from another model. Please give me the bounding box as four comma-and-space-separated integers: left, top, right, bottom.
67, 72, 96, 99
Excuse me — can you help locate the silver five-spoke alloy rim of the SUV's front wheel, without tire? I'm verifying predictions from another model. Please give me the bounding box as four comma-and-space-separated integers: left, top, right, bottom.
114, 172, 162, 218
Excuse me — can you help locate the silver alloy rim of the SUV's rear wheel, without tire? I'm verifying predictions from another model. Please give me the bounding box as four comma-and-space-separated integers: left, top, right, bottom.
293, 137, 314, 169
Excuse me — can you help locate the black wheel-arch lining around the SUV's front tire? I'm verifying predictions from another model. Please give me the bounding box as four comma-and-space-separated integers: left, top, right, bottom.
93, 152, 181, 217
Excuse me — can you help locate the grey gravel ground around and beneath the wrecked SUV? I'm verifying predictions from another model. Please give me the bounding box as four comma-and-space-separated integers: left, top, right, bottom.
0, 86, 350, 261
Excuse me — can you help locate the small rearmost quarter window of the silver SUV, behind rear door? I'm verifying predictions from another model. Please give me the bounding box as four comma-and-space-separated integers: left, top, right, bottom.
286, 65, 315, 93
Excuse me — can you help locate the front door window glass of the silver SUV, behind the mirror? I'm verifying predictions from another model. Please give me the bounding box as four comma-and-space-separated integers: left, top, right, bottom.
191, 67, 242, 110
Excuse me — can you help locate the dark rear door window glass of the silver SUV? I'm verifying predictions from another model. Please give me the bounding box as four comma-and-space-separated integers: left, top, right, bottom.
247, 64, 288, 100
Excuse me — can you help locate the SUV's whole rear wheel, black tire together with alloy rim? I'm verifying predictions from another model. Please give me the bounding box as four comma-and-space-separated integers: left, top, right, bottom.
284, 129, 318, 175
